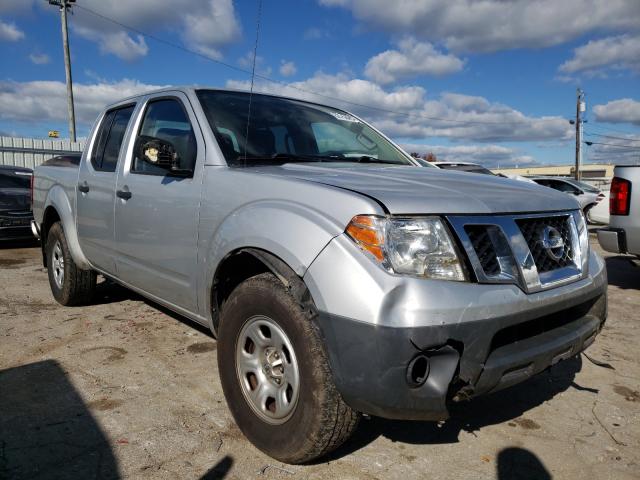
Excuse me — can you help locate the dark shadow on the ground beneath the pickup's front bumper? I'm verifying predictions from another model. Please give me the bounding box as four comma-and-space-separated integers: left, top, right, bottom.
323, 356, 584, 461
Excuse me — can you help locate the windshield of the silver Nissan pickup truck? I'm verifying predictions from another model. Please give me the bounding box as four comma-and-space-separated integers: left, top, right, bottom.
197, 90, 413, 166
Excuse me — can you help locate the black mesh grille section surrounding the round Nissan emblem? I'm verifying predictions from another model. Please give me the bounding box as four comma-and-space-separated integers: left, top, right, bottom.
516, 215, 574, 273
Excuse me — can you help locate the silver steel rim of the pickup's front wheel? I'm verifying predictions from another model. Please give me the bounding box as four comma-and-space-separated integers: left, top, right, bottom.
236, 315, 300, 425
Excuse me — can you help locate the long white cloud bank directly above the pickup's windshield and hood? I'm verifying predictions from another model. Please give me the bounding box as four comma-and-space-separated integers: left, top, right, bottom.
227, 73, 572, 142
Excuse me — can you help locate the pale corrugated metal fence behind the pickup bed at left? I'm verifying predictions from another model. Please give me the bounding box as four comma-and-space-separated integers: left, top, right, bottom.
0, 137, 84, 168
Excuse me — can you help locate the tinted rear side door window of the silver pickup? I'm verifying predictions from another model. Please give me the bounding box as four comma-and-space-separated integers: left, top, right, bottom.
91, 105, 134, 172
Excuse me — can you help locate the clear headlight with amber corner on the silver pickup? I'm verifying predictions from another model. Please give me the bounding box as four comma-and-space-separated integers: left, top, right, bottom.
346, 215, 466, 281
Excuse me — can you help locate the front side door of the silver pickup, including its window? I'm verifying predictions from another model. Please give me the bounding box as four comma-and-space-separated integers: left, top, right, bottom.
115, 92, 204, 312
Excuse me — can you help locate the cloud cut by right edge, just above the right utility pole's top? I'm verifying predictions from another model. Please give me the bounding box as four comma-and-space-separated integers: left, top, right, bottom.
559, 35, 640, 74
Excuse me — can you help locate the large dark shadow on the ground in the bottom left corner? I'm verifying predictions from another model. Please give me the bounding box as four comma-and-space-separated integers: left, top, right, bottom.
0, 360, 120, 479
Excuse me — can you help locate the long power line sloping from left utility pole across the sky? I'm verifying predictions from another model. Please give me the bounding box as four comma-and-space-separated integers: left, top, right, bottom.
76, 4, 522, 128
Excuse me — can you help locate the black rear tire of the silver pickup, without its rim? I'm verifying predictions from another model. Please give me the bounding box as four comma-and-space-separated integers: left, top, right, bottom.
45, 222, 97, 306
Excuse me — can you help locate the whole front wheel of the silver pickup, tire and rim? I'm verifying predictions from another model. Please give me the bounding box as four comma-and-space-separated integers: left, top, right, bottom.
218, 274, 359, 463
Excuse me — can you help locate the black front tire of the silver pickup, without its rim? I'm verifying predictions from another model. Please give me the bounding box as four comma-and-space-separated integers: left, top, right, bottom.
218, 274, 360, 464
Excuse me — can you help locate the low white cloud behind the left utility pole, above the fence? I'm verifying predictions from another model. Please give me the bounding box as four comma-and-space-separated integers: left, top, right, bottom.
0, 79, 160, 127
